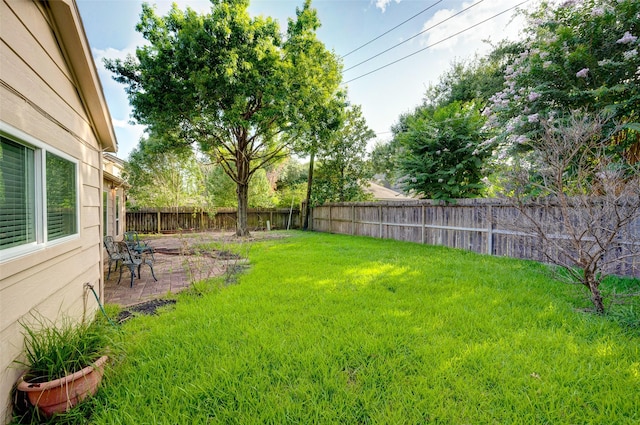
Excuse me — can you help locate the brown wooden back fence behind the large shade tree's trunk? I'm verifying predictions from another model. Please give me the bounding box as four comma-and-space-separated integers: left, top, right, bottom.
126, 208, 300, 233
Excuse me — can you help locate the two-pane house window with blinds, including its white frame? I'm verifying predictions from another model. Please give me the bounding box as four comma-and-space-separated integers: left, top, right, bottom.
0, 122, 79, 259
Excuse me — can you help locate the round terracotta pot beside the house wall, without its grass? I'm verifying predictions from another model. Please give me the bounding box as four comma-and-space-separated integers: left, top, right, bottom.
17, 356, 109, 417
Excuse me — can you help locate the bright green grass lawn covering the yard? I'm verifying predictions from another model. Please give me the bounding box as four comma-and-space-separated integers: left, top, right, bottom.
45, 232, 640, 424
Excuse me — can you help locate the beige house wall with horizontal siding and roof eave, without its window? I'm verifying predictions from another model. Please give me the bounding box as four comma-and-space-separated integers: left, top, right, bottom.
0, 0, 115, 423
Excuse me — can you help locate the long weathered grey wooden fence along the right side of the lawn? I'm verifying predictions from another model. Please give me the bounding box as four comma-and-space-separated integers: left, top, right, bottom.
310, 199, 640, 276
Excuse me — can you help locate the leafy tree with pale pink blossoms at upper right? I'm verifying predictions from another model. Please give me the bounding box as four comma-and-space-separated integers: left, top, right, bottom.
483, 0, 640, 163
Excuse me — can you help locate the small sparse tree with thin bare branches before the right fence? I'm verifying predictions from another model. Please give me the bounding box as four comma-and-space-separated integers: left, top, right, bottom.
504, 111, 640, 313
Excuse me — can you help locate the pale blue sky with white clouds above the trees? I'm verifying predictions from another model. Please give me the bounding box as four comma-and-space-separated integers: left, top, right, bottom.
76, 0, 535, 160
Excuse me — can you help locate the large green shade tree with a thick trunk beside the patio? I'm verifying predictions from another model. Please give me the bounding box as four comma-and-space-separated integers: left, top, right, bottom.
106, 0, 341, 236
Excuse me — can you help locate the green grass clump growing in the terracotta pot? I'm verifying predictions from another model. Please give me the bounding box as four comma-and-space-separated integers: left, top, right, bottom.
16, 315, 111, 383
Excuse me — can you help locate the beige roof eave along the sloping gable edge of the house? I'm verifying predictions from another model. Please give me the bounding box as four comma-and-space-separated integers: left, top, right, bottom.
43, 0, 118, 152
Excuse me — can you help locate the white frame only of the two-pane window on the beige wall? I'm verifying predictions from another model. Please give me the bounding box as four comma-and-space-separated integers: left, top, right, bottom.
0, 121, 81, 263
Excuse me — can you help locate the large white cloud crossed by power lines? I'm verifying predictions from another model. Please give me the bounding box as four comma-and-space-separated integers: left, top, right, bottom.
421, 0, 524, 55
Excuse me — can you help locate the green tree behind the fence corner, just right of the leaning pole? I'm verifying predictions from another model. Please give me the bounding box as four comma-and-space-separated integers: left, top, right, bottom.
313, 106, 376, 204
